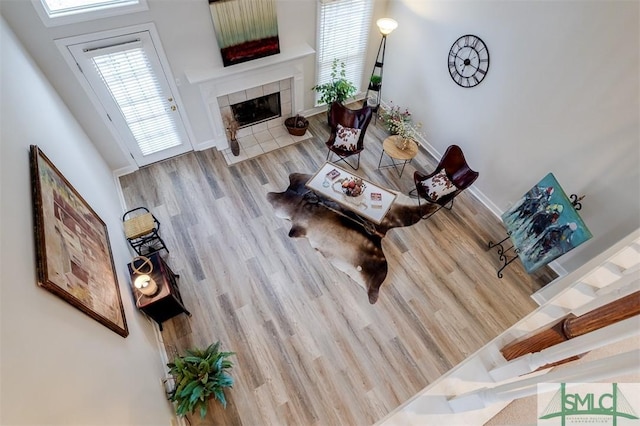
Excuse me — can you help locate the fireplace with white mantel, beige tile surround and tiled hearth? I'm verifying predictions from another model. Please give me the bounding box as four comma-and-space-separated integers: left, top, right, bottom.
192, 45, 314, 164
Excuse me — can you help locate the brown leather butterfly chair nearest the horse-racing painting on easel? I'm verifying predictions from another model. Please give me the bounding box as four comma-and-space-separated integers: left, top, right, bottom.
409, 145, 479, 219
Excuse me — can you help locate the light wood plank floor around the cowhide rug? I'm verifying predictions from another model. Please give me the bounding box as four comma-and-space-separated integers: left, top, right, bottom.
120, 109, 554, 425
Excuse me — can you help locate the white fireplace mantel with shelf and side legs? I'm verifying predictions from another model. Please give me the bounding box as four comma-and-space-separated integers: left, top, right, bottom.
192, 43, 315, 150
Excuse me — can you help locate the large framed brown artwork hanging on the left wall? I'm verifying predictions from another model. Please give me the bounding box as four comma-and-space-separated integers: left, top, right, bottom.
30, 145, 129, 337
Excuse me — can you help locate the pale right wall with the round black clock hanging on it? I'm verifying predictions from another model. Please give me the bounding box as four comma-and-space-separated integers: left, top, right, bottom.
383, 0, 640, 271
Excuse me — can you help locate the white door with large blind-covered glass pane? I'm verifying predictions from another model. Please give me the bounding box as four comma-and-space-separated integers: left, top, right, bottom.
61, 26, 192, 166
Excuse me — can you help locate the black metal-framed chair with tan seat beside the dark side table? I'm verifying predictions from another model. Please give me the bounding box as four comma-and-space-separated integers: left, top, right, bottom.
122, 207, 169, 256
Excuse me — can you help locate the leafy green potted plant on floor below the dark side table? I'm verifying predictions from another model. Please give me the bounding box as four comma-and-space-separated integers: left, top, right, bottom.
167, 342, 235, 417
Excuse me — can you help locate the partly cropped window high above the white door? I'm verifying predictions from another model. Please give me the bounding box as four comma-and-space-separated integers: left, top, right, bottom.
31, 0, 148, 27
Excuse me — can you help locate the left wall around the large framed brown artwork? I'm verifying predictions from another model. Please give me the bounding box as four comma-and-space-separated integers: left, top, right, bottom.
0, 19, 172, 425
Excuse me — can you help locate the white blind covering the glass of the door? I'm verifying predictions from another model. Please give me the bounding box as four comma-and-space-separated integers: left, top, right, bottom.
88, 43, 182, 155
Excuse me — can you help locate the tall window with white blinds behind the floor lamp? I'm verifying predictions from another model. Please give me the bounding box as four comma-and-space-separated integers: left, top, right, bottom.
316, 0, 373, 104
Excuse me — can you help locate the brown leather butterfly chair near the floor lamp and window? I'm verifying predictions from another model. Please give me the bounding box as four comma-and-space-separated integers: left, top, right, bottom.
326, 102, 373, 170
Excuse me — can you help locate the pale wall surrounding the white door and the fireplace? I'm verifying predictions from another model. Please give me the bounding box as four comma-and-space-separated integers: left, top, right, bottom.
0, 0, 320, 170
